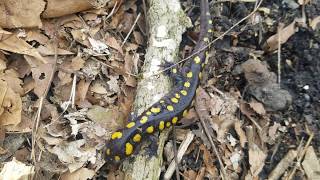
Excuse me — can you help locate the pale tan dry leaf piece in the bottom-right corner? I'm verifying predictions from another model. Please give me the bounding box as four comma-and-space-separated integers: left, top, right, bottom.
302, 146, 320, 179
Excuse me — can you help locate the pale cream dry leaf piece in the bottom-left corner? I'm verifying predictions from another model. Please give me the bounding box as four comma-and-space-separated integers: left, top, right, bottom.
0, 158, 35, 180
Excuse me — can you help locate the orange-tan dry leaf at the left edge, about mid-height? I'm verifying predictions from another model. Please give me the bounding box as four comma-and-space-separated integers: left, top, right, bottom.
0, 79, 22, 126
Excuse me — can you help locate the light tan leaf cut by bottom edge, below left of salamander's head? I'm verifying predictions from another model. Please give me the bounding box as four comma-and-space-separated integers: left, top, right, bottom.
61, 168, 96, 180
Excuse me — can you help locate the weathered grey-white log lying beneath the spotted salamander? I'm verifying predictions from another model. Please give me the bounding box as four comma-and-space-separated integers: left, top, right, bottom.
123, 0, 191, 180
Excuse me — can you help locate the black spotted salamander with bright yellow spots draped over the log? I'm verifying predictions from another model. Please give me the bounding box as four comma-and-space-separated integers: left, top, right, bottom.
106, 0, 212, 164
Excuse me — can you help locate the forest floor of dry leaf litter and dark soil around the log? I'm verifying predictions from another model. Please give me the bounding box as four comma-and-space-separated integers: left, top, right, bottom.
0, 0, 320, 180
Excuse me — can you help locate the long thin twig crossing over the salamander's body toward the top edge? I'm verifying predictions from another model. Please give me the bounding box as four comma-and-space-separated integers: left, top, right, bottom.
146, 0, 263, 78
